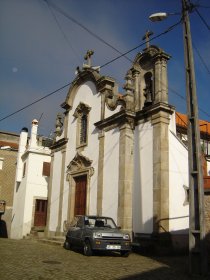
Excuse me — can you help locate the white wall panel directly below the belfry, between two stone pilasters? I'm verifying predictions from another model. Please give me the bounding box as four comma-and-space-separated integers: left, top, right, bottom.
133, 122, 153, 233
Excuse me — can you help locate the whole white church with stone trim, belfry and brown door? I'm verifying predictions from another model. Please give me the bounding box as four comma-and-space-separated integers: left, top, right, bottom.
45, 46, 189, 249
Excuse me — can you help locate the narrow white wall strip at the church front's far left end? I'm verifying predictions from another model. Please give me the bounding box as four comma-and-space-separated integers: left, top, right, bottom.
48, 151, 62, 232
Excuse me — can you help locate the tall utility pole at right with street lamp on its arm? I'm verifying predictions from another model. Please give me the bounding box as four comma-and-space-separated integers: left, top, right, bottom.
149, 0, 207, 274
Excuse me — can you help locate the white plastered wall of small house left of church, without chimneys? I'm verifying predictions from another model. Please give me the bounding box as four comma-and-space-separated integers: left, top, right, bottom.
11, 152, 51, 239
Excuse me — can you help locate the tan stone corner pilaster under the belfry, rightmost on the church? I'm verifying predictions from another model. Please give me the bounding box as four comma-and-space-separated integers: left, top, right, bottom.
152, 111, 170, 233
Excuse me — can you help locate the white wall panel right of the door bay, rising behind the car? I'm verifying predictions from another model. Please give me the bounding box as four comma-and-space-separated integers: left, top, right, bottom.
102, 128, 119, 223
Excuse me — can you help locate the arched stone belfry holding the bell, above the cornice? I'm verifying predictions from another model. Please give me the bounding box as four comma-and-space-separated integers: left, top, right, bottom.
132, 44, 170, 111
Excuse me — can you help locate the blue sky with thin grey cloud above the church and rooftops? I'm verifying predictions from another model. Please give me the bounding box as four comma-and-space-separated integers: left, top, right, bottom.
0, 0, 210, 136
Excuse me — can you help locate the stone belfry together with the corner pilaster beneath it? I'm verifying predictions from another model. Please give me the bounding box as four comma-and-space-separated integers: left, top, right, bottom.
131, 43, 174, 236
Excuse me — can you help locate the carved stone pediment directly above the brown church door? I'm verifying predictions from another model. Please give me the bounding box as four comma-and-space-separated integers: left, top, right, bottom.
67, 152, 94, 175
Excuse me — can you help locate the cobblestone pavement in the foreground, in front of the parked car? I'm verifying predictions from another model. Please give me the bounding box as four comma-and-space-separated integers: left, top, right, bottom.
0, 238, 210, 280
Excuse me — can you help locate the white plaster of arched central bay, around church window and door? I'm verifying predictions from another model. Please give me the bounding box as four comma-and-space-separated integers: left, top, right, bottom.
63, 81, 101, 219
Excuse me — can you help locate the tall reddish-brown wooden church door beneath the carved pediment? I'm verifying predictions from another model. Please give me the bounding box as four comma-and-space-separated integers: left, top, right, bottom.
74, 176, 87, 215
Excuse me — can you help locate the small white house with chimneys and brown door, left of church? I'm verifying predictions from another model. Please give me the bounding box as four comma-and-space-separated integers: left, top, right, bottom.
11, 120, 52, 238
